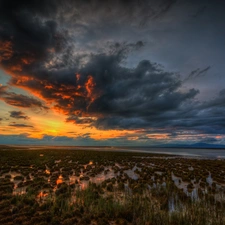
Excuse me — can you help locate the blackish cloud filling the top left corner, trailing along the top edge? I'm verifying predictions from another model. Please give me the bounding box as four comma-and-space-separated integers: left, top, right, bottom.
0, 0, 174, 76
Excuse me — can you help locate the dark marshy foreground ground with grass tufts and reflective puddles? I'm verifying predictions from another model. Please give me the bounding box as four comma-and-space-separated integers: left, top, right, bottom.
0, 146, 225, 225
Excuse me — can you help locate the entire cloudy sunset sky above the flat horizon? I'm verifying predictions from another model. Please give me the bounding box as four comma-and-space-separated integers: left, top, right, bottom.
0, 0, 225, 146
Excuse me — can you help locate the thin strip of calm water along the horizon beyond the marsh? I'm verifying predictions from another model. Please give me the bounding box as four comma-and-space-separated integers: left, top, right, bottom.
5, 146, 225, 159
